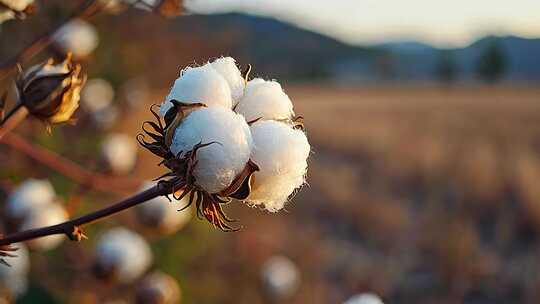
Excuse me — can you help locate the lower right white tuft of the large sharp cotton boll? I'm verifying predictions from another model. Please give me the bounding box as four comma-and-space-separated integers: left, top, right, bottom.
247, 120, 310, 212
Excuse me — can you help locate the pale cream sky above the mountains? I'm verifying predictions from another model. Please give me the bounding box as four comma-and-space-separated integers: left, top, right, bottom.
185, 0, 540, 47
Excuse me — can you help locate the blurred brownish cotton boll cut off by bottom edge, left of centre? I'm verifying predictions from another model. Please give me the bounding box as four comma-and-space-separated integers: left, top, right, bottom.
135, 271, 181, 304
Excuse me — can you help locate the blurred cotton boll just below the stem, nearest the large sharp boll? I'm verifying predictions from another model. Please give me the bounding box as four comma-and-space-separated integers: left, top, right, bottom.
134, 182, 193, 234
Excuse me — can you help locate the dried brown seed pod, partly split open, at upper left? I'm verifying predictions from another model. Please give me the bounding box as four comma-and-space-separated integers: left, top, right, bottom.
16, 55, 86, 124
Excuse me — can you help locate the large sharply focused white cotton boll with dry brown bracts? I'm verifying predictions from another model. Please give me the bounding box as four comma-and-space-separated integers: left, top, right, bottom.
138, 57, 310, 231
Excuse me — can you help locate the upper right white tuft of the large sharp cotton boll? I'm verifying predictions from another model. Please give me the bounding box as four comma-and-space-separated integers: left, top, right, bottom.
235, 78, 294, 121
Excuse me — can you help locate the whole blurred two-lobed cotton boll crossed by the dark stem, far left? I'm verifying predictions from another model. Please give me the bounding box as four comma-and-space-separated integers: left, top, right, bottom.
5, 179, 68, 251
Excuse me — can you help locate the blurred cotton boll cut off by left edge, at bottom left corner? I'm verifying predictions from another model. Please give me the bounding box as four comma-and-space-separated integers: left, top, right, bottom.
0, 243, 30, 303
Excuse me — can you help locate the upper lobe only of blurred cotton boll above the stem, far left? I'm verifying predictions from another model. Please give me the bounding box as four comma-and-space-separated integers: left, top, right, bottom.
6, 179, 56, 219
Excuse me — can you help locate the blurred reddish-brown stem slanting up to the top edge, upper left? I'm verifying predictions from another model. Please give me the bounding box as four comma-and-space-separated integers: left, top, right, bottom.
0, 0, 104, 80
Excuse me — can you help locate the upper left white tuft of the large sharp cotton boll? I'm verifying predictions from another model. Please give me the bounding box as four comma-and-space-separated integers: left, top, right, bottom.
160, 64, 232, 115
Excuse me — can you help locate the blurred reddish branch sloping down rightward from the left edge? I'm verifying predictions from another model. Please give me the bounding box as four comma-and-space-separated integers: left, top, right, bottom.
0, 133, 142, 194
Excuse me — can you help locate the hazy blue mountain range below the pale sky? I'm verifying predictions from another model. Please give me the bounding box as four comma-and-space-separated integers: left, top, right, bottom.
176, 14, 540, 83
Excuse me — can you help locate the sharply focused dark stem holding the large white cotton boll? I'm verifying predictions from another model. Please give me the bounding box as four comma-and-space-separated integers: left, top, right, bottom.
0, 184, 171, 246
